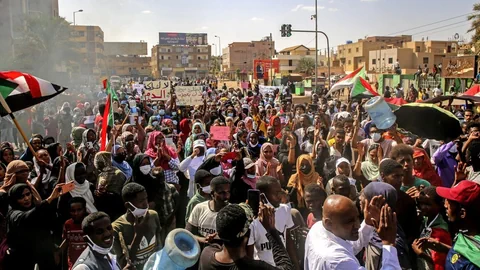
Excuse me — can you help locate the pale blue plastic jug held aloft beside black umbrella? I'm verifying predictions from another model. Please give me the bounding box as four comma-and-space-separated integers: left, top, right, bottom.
364, 96, 397, 129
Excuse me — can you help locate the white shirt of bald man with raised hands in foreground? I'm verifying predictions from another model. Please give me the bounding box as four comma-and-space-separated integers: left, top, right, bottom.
305, 222, 401, 270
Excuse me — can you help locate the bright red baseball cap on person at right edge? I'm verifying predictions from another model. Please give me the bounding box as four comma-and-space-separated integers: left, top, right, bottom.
437, 180, 480, 206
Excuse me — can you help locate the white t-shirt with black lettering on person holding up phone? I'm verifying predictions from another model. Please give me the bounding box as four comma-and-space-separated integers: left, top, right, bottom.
248, 204, 294, 266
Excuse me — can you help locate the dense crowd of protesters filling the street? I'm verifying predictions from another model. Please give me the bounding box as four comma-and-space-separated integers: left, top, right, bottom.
0, 77, 480, 270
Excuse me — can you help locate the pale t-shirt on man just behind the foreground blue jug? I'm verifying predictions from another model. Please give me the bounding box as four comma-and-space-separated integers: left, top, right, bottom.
188, 201, 218, 237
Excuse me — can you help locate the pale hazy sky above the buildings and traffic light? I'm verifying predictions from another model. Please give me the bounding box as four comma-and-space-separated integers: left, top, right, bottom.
59, 0, 477, 55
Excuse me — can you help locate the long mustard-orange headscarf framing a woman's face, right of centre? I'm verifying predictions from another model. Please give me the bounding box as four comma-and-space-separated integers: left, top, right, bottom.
287, 155, 320, 208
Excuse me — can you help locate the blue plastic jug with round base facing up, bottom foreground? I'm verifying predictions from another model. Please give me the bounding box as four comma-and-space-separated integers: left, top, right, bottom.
143, 229, 200, 270
